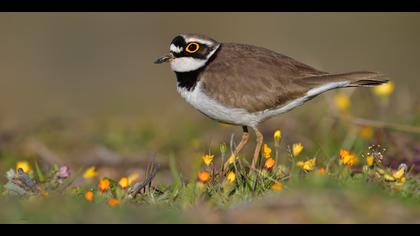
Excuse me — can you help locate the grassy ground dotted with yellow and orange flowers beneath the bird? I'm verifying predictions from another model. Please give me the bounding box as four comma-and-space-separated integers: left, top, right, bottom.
0, 85, 420, 223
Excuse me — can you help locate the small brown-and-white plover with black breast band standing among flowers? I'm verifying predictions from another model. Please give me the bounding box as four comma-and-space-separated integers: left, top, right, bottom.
154, 33, 388, 170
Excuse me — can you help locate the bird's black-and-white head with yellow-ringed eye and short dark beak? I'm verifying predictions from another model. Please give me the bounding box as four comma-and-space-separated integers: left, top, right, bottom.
155, 34, 220, 72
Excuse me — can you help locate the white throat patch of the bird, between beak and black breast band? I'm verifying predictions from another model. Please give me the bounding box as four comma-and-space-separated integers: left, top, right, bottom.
171, 45, 219, 72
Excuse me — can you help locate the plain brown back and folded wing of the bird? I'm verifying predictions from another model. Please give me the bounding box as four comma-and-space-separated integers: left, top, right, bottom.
199, 43, 328, 112
